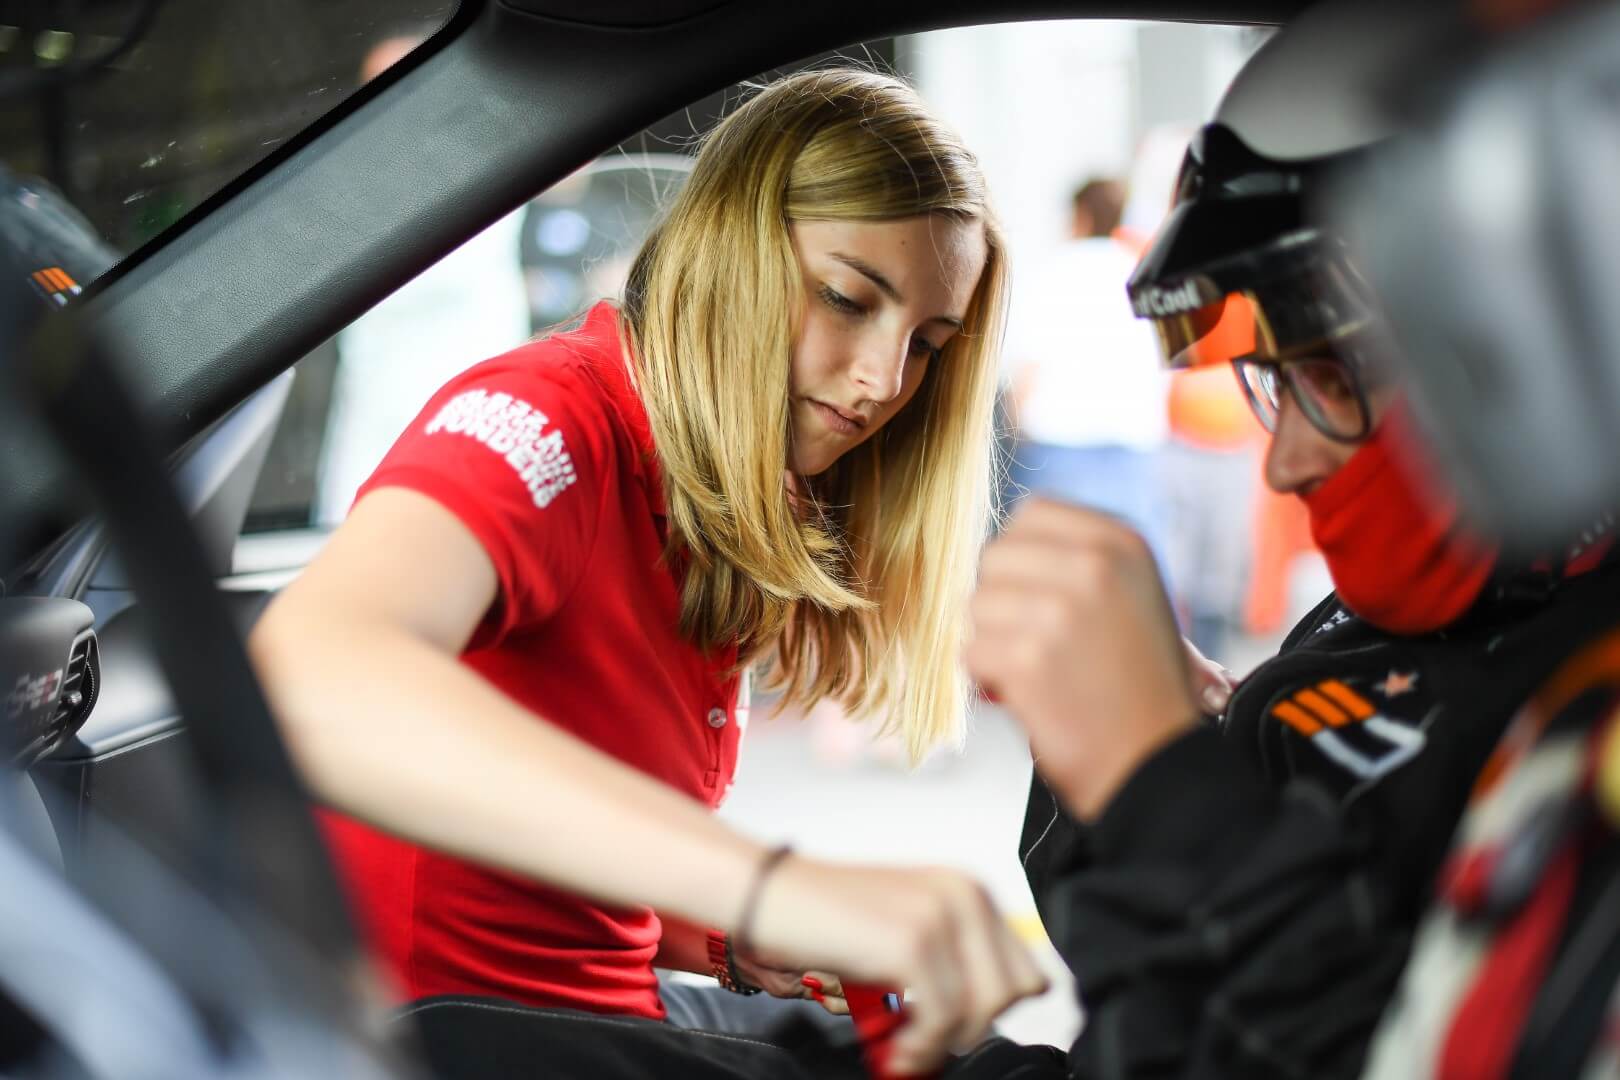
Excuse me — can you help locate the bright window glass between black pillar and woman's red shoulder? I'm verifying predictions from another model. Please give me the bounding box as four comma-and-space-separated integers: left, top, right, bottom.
246, 151, 690, 537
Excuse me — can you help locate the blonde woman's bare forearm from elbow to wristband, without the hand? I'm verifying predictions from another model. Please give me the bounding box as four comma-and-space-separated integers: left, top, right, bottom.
249, 607, 763, 929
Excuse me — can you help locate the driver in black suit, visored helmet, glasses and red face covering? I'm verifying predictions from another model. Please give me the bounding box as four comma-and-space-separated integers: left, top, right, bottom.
967, 6, 1620, 1077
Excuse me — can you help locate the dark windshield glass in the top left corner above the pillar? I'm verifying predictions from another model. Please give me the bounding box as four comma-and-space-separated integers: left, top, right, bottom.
0, 0, 457, 295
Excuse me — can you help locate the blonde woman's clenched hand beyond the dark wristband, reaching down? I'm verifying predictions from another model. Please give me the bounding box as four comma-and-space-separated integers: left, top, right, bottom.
744, 857, 1047, 1075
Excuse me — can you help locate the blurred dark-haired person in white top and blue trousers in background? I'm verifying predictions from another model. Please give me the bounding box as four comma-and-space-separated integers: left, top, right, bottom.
1003, 176, 1166, 579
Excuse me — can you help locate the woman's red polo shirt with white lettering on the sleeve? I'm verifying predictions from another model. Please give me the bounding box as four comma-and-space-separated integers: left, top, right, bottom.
327, 304, 747, 1017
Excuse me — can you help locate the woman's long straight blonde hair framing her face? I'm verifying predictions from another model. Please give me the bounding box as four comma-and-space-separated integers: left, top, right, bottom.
620, 70, 1006, 758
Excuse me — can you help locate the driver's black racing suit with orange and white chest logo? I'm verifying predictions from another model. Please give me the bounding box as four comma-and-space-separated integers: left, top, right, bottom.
1010, 559, 1620, 1080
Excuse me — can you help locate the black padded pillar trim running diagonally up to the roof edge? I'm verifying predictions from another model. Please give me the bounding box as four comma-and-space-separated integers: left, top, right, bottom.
0, 0, 1304, 553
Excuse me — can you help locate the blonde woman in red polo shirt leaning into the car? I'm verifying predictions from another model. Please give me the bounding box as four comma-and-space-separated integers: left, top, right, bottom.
251, 71, 1040, 1067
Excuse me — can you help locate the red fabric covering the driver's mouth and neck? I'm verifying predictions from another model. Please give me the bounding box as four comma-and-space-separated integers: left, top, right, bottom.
1301, 402, 1497, 635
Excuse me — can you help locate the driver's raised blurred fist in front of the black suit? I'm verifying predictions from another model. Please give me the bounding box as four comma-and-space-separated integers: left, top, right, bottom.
964, 499, 1205, 819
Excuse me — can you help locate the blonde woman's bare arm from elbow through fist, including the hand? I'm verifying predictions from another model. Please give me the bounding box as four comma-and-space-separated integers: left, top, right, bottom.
249, 597, 1042, 1069
